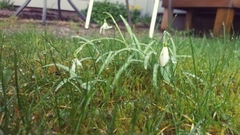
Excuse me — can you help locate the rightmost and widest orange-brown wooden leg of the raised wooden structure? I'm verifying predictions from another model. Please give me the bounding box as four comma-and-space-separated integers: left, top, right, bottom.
213, 8, 234, 36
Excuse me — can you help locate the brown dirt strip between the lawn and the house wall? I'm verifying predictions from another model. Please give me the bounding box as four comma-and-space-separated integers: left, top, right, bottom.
0, 8, 161, 36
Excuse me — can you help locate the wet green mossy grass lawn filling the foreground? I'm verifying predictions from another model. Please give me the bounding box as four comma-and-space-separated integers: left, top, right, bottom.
0, 16, 240, 134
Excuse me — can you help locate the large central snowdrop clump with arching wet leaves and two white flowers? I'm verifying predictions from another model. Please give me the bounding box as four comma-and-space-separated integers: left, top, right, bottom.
74, 12, 180, 88
